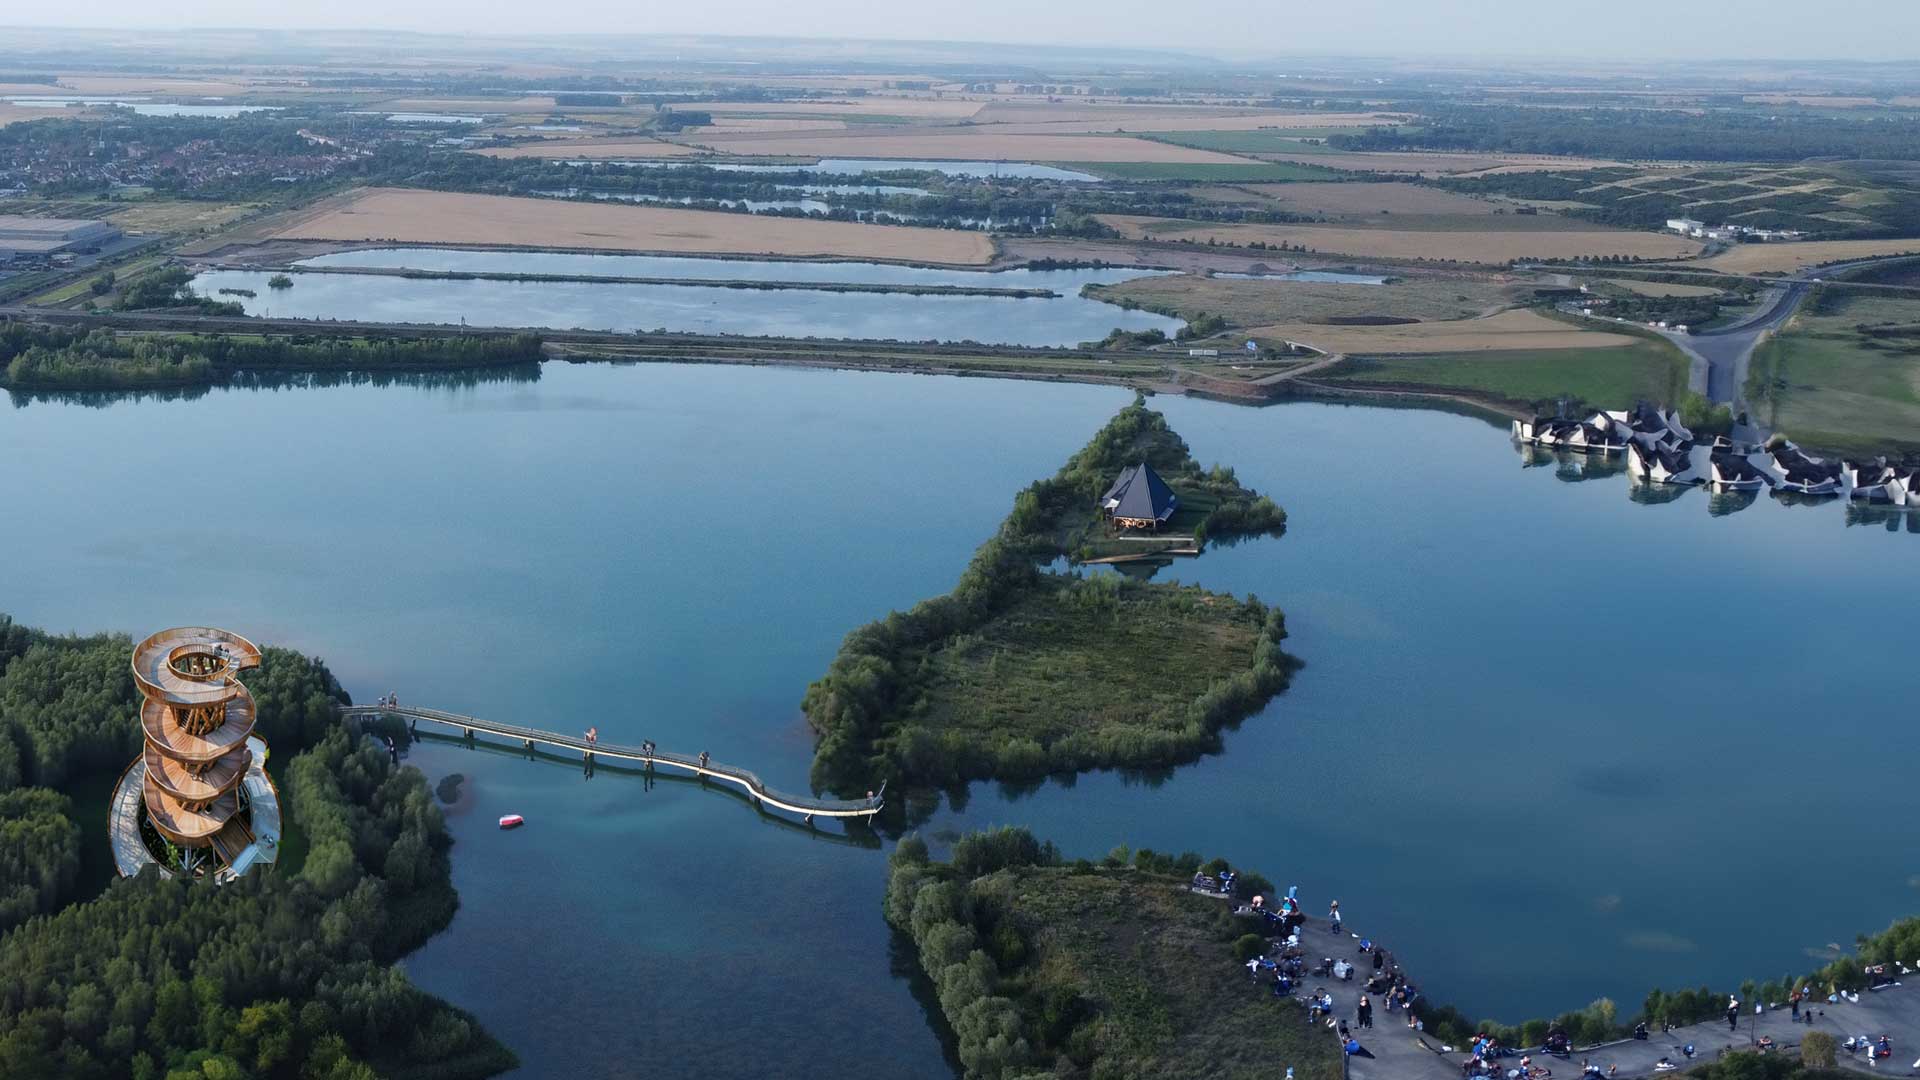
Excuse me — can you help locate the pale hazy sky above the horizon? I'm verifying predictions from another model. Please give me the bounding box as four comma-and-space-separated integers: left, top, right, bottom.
11, 0, 1920, 63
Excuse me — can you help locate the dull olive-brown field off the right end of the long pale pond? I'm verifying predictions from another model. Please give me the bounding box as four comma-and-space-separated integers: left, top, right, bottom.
1085, 275, 1523, 327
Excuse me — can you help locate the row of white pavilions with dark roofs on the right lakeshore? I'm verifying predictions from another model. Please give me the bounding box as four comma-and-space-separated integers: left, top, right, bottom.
1513, 405, 1920, 507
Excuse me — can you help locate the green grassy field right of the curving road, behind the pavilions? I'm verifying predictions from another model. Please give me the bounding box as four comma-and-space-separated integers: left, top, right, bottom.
1745, 292, 1920, 454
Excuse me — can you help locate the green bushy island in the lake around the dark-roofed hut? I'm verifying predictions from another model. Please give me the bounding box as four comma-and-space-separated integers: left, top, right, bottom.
803, 400, 1294, 792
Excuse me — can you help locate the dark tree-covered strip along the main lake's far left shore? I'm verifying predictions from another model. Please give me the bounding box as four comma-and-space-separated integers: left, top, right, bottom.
0, 323, 541, 390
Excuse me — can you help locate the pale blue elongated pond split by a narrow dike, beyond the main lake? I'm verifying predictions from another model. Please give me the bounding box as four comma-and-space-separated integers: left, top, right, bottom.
194, 248, 1183, 346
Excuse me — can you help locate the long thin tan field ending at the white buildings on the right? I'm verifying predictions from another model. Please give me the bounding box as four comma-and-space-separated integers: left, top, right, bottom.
1098, 213, 1704, 265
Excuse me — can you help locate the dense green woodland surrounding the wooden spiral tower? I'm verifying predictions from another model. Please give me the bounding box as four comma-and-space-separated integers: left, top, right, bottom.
0, 615, 516, 1080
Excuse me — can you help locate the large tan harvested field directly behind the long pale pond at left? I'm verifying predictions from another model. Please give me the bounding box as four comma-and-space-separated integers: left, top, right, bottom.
271, 188, 993, 265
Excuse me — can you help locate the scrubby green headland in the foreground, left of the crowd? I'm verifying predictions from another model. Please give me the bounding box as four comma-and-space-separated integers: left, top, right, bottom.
885, 828, 1342, 1080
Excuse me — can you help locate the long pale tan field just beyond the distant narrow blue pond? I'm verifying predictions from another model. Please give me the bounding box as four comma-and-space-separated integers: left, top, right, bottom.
691, 129, 1250, 165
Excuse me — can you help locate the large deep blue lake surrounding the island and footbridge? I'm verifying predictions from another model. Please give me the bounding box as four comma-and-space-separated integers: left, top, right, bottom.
0, 365, 1920, 1078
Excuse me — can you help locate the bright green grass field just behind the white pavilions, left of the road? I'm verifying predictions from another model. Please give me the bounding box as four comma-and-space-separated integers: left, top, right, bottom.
1317, 338, 1688, 411
